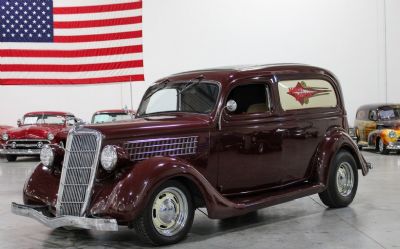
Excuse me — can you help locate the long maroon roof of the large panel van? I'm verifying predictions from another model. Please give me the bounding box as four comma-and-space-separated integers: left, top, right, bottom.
156, 63, 335, 84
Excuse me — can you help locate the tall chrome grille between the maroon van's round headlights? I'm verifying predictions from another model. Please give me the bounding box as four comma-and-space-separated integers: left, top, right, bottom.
56, 129, 101, 216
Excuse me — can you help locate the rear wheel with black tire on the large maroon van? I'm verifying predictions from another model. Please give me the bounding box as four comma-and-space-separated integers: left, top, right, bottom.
319, 151, 358, 208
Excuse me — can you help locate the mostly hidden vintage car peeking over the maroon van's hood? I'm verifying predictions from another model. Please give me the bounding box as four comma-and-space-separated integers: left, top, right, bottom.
91, 109, 135, 124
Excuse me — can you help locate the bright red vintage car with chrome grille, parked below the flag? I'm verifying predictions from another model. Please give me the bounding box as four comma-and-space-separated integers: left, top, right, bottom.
0, 111, 76, 162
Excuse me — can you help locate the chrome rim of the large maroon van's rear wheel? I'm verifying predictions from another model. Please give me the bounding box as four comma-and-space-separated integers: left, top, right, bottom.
336, 162, 354, 197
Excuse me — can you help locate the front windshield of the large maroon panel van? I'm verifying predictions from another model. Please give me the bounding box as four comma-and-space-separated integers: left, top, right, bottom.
138, 82, 219, 116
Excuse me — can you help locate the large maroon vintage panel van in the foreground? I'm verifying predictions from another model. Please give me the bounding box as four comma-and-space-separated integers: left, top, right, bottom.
12, 64, 370, 245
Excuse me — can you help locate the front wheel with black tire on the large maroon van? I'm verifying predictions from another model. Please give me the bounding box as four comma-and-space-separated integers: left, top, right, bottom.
133, 181, 194, 246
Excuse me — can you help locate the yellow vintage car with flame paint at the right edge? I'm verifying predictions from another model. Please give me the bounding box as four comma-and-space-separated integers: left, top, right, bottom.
354, 104, 400, 154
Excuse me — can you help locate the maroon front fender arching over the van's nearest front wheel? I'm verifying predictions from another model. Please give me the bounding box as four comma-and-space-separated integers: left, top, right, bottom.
90, 157, 244, 224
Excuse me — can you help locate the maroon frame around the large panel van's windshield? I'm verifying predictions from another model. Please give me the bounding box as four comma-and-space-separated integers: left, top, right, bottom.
135, 79, 222, 118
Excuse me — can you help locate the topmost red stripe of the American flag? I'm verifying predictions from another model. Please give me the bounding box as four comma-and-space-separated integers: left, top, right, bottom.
53, 1, 142, 15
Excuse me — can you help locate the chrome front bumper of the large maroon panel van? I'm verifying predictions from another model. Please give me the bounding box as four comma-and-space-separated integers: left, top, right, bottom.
11, 202, 118, 231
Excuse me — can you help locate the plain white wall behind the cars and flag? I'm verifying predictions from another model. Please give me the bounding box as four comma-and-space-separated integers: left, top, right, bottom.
0, 0, 394, 124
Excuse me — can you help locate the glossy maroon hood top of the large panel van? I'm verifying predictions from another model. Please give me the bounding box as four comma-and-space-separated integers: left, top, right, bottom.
85, 114, 211, 140
